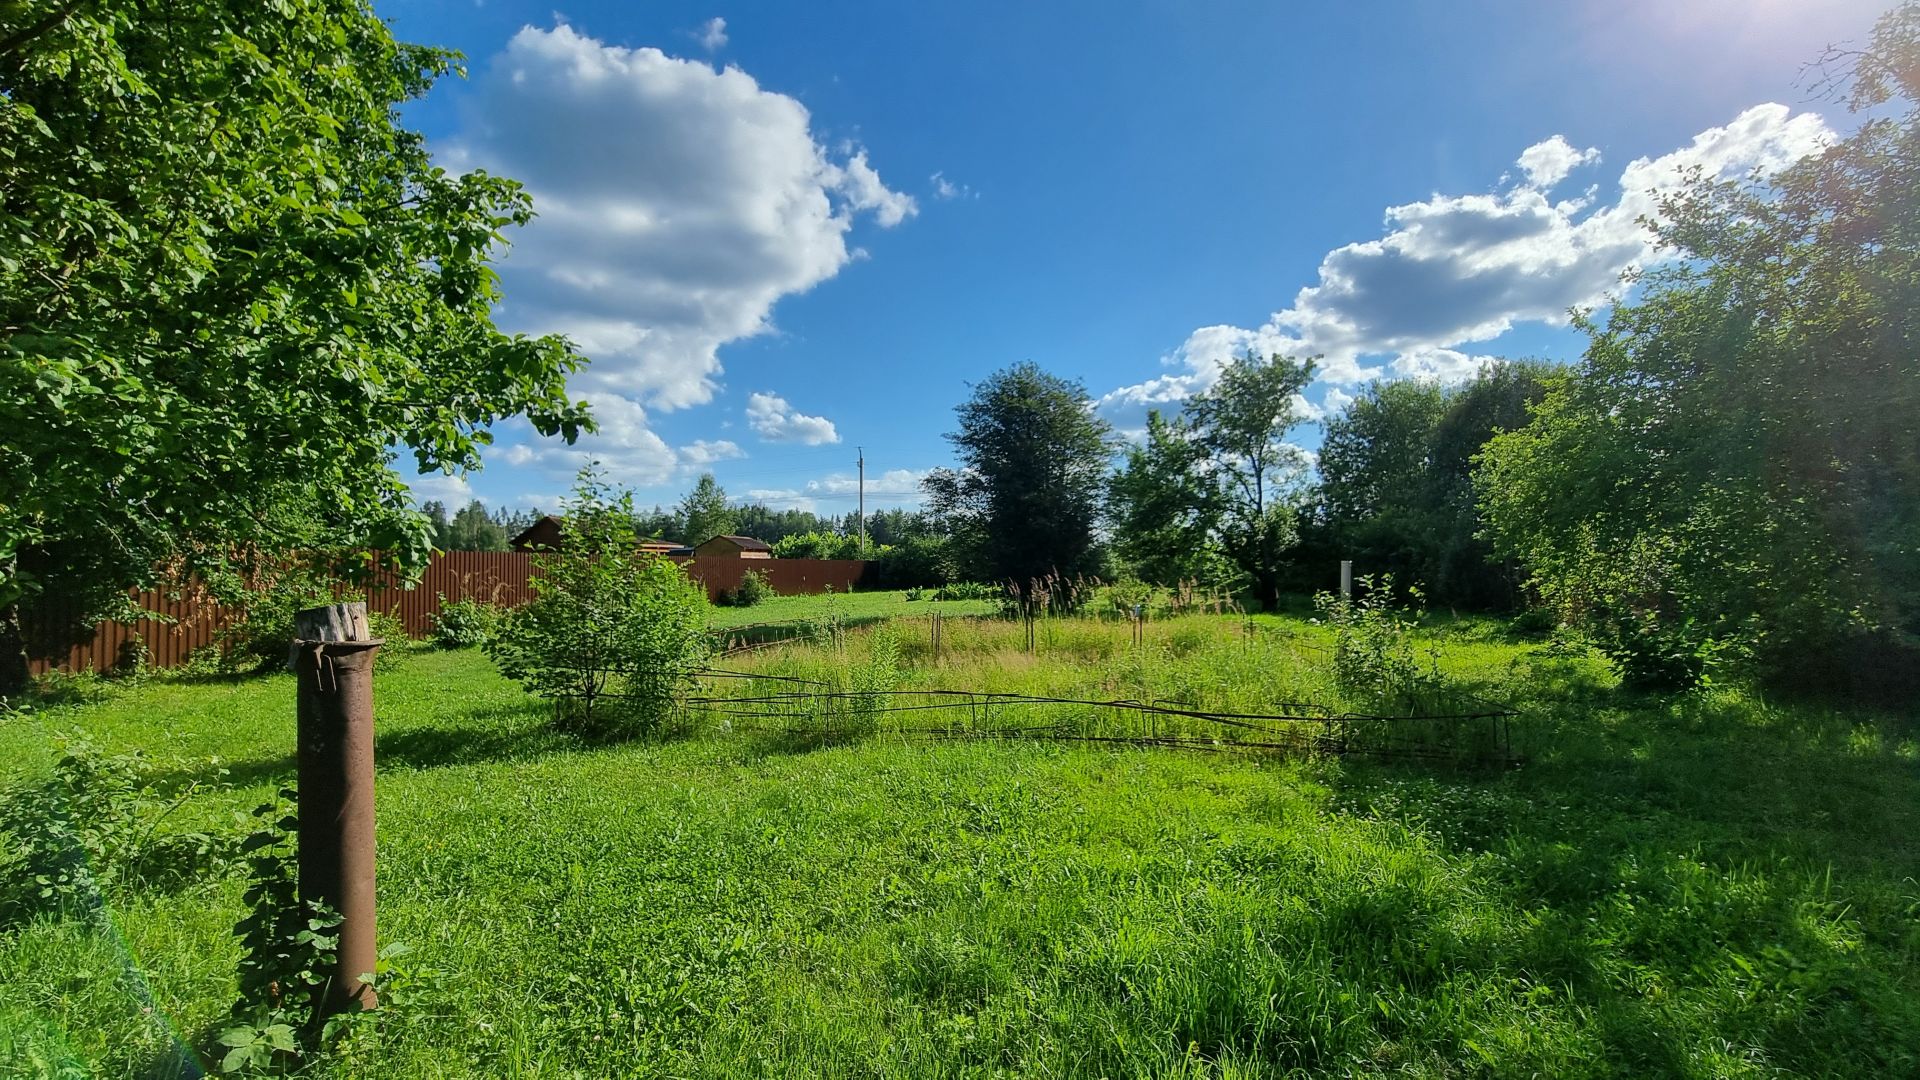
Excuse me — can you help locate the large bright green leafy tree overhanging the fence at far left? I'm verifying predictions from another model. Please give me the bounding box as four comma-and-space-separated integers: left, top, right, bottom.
0, 0, 588, 692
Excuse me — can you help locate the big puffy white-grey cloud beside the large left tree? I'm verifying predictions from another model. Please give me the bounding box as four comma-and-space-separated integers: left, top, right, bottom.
436, 25, 916, 409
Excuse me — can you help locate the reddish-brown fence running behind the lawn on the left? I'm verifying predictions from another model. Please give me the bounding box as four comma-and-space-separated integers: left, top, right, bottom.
29, 552, 876, 675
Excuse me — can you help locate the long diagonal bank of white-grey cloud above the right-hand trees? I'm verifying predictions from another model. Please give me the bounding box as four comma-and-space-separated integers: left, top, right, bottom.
1100, 104, 1832, 427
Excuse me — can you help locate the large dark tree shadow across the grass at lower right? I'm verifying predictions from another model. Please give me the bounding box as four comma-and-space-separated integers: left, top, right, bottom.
1329, 676, 1920, 1074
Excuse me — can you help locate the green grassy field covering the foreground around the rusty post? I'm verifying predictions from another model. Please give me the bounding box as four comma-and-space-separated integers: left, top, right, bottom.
0, 598, 1920, 1078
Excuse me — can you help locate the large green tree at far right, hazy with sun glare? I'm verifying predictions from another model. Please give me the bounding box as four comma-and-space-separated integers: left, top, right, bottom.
1480, 4, 1920, 686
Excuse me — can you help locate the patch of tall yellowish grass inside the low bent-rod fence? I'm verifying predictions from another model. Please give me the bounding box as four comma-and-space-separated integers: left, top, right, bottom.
695, 615, 1505, 761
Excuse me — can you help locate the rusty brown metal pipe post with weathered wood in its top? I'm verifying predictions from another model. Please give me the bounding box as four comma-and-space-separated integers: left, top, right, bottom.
294, 603, 382, 1015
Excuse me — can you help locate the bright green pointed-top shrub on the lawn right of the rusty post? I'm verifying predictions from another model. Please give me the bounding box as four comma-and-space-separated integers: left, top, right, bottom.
486, 473, 710, 734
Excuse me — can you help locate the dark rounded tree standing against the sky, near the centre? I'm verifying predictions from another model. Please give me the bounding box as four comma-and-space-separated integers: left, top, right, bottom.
924, 361, 1110, 603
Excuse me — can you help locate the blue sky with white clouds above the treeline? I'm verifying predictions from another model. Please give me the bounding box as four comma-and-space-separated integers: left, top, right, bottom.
380, 0, 1882, 513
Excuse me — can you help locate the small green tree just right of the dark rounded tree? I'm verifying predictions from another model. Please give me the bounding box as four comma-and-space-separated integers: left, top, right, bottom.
1106, 409, 1225, 584
